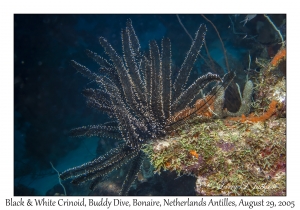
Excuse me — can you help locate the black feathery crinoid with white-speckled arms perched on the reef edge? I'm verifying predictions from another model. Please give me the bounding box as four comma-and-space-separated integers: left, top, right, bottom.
60, 20, 235, 195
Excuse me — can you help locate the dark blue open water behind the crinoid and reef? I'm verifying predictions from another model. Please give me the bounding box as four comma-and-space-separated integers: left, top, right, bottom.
14, 14, 286, 196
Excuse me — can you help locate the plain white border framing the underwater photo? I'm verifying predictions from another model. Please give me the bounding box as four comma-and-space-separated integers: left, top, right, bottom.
0, 0, 300, 209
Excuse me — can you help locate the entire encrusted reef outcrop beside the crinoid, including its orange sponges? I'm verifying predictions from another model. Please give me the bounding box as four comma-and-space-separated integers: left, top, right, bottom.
143, 41, 286, 196
